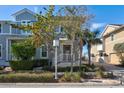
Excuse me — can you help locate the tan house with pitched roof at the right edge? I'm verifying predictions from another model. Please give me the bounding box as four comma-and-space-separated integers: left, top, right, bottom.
92, 24, 124, 64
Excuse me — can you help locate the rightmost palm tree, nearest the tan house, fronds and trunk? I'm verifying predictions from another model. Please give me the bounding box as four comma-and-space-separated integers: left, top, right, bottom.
85, 30, 102, 65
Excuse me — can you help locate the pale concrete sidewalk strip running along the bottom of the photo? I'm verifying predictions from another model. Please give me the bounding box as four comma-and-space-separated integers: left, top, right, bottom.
0, 80, 121, 88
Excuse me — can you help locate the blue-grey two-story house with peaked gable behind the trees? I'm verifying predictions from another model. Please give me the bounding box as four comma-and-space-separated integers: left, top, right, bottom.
0, 8, 78, 66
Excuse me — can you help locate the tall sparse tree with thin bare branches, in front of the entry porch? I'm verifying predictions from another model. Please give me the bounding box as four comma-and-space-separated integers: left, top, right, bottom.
59, 6, 91, 73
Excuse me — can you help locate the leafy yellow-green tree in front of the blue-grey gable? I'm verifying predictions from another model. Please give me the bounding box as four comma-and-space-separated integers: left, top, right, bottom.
12, 5, 57, 47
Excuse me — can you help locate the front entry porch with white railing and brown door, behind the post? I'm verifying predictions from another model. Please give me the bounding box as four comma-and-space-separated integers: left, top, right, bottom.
52, 40, 80, 67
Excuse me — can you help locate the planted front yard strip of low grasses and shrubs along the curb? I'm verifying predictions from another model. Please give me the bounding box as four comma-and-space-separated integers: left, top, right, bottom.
0, 64, 119, 83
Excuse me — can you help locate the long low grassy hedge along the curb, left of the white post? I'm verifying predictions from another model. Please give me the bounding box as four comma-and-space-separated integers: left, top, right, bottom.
0, 72, 55, 83
